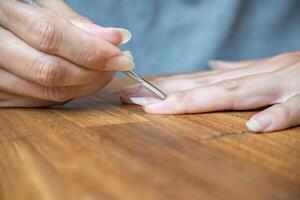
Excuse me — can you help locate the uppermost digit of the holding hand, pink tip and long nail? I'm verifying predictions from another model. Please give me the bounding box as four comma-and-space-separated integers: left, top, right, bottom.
39, 0, 131, 45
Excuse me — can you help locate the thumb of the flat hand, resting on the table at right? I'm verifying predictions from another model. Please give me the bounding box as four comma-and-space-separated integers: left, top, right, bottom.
247, 94, 300, 132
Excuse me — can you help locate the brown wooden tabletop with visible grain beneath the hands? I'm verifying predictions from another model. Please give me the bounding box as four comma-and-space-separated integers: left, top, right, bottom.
0, 80, 300, 200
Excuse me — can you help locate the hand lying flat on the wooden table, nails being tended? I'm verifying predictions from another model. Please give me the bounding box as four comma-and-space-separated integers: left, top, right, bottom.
121, 52, 300, 132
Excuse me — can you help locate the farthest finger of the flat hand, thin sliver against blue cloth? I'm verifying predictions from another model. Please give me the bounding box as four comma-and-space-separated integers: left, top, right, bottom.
208, 60, 257, 70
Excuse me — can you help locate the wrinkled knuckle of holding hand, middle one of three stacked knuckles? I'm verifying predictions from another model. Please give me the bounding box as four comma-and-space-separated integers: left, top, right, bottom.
31, 56, 63, 87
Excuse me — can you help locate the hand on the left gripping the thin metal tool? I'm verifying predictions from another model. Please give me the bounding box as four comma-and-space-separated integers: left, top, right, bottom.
0, 0, 134, 107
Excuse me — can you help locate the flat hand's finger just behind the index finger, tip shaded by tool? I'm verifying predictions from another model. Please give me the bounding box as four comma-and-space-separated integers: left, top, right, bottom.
120, 56, 299, 103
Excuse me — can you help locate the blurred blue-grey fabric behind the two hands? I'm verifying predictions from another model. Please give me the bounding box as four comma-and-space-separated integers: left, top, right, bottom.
66, 0, 300, 75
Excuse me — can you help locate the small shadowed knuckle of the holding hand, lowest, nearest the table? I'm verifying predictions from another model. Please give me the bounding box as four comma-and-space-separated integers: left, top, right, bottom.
46, 87, 73, 103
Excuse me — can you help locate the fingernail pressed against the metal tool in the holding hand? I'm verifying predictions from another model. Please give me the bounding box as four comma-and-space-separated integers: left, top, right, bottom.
104, 56, 135, 71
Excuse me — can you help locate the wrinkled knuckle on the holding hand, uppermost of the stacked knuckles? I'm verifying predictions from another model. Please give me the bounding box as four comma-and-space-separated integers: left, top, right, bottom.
32, 19, 62, 52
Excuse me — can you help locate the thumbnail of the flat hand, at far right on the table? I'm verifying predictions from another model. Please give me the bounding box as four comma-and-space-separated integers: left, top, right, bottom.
246, 113, 272, 133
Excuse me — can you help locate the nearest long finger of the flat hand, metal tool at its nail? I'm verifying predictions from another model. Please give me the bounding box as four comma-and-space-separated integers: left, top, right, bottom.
131, 74, 281, 114
